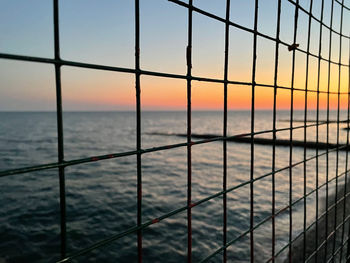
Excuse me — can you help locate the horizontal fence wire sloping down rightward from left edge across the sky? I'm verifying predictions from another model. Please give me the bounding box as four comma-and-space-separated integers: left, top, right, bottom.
0, 53, 349, 95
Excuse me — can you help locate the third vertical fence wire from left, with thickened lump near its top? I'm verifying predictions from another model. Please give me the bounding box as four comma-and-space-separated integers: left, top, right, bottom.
186, 0, 193, 263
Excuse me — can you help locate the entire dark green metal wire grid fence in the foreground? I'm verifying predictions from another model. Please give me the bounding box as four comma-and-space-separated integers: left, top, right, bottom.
0, 0, 350, 262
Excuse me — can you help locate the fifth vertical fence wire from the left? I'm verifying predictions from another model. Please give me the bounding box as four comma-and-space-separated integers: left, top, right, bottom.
249, 0, 259, 262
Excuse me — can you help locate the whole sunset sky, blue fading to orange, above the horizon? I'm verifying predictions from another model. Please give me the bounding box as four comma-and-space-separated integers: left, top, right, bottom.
0, 0, 350, 111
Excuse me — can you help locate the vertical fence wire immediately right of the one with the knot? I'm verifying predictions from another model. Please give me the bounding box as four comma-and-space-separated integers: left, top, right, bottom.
303, 0, 316, 261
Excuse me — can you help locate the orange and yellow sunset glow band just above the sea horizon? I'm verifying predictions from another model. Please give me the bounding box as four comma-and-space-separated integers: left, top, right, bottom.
58, 64, 348, 110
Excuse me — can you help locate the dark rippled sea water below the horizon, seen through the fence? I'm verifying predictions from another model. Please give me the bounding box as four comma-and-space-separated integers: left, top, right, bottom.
0, 110, 347, 262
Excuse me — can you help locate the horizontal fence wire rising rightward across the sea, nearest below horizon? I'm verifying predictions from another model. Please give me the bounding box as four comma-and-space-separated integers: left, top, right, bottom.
0, 120, 346, 177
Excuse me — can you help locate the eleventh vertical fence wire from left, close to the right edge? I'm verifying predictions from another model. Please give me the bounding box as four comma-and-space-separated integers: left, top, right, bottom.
332, 0, 345, 262
